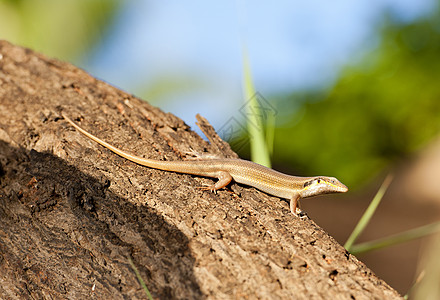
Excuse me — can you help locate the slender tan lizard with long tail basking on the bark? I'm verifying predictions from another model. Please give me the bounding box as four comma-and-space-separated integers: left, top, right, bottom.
61, 113, 348, 216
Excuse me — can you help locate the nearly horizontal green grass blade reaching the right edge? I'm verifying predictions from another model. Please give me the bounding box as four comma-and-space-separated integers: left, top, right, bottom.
349, 222, 440, 255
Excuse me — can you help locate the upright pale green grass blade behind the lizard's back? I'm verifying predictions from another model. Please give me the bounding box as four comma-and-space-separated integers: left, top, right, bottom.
243, 50, 271, 168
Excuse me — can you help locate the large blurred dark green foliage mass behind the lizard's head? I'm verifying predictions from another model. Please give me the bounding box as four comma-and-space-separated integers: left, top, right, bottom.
274, 12, 440, 186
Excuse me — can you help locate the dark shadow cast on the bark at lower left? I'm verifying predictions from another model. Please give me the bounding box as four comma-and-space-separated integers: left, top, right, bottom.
0, 141, 202, 299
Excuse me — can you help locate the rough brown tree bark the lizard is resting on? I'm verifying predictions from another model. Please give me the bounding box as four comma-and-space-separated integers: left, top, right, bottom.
0, 41, 400, 299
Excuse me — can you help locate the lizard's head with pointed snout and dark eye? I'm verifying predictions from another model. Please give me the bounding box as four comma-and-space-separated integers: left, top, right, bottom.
299, 176, 348, 198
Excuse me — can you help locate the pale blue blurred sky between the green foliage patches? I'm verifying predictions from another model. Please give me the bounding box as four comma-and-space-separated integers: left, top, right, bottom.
84, 0, 436, 127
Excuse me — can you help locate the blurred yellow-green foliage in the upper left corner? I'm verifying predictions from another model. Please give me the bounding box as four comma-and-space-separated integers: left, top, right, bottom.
0, 0, 122, 61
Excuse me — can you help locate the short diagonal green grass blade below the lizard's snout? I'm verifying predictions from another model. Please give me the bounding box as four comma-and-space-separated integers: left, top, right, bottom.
344, 175, 393, 253
